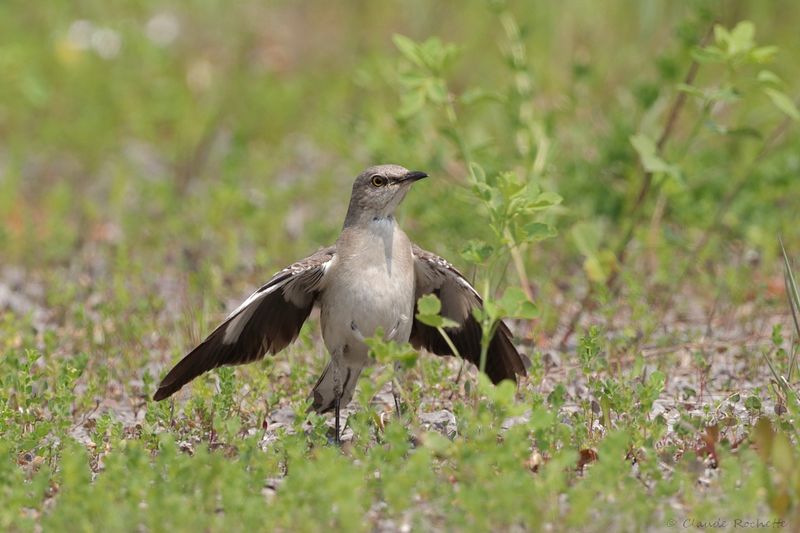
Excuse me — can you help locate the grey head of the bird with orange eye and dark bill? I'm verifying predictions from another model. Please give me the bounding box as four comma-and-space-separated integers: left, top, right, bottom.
345, 165, 428, 226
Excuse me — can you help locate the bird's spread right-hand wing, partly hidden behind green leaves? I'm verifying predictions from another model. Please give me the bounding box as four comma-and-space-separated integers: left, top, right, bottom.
410, 246, 529, 383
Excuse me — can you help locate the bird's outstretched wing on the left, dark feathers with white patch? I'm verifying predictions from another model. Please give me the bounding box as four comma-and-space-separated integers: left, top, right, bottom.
153, 246, 336, 400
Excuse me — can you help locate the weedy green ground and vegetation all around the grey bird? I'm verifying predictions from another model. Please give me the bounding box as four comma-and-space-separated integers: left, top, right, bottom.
0, 0, 800, 531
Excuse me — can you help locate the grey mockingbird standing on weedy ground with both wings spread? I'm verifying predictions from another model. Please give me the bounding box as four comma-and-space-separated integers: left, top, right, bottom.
153, 165, 527, 442
